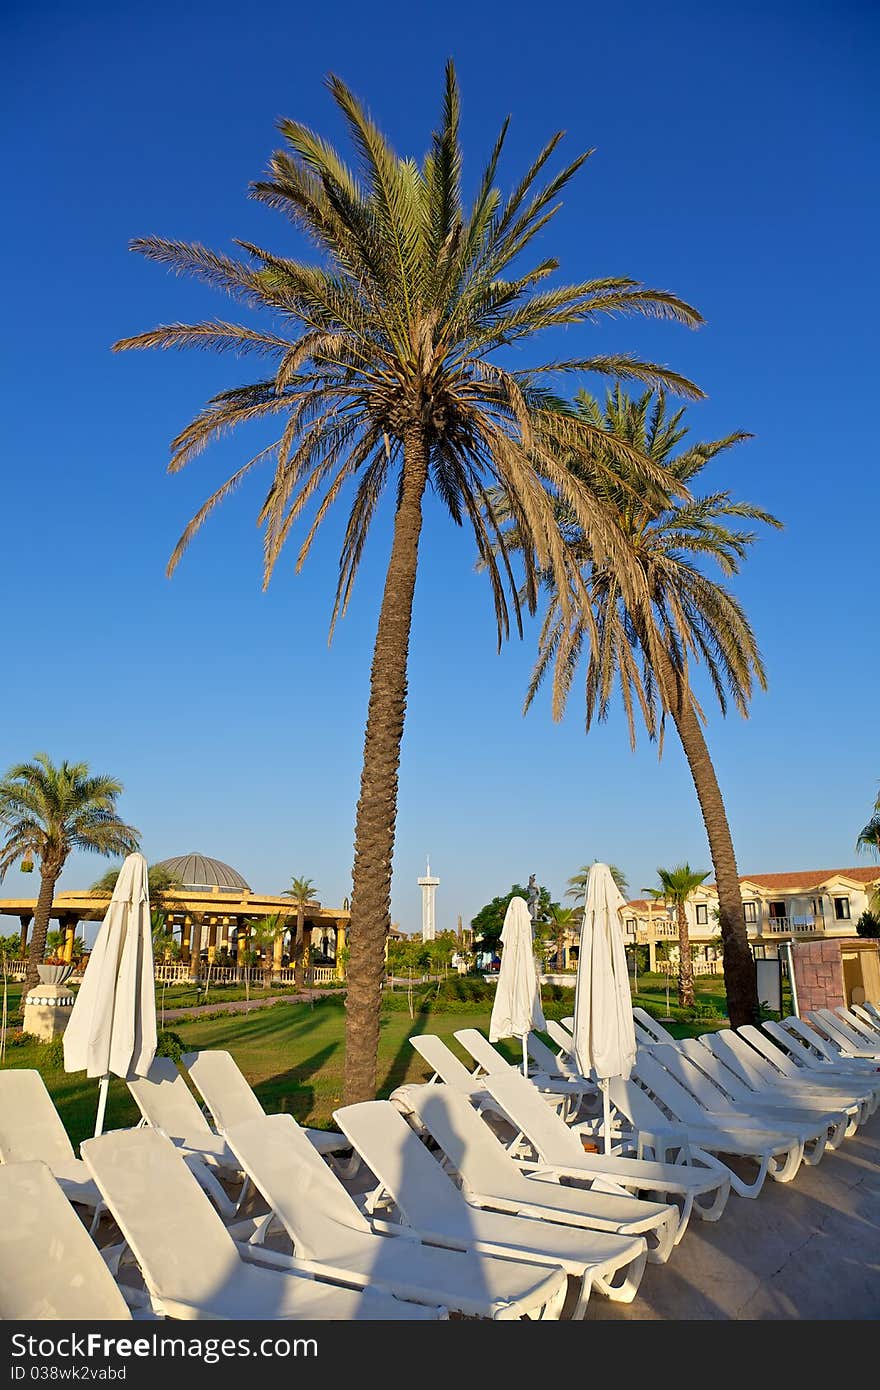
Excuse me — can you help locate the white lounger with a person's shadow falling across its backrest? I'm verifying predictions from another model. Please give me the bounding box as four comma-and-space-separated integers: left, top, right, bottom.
334, 1101, 648, 1318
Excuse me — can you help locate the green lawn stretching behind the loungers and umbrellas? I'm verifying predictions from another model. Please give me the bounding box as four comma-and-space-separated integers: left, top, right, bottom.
4, 974, 756, 1144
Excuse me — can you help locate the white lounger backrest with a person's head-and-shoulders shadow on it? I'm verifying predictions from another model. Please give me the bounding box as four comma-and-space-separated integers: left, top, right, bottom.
334, 1101, 471, 1241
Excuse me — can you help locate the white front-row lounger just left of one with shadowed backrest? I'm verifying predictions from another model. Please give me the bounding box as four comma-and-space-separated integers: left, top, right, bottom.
227, 1115, 567, 1319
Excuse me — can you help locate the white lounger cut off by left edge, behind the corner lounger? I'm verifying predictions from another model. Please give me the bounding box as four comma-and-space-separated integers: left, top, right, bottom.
0, 1068, 101, 1230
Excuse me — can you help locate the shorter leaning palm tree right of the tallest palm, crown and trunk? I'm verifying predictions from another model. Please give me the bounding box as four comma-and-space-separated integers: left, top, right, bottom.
508, 385, 781, 1027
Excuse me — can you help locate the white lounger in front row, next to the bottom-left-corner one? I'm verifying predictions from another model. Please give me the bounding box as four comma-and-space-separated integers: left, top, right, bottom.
82, 1129, 446, 1321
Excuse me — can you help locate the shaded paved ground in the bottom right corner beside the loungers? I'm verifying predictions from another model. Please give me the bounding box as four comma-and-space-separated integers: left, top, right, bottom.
587, 1109, 880, 1322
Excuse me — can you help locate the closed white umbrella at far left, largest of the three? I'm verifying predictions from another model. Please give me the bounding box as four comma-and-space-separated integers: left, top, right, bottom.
64, 855, 156, 1136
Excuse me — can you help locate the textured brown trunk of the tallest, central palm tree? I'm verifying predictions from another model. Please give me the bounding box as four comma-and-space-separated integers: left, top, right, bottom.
343, 424, 428, 1105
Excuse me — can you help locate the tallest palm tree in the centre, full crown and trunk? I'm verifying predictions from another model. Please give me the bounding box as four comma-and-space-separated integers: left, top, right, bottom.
114, 64, 702, 1104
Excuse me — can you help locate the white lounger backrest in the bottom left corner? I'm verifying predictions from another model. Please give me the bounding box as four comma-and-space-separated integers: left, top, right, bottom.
0, 1162, 131, 1322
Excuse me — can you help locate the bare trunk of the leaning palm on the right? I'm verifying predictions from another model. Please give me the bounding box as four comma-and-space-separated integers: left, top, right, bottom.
671, 696, 758, 1029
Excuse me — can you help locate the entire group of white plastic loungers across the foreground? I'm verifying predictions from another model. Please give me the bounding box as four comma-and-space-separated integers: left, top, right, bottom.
0, 1009, 880, 1321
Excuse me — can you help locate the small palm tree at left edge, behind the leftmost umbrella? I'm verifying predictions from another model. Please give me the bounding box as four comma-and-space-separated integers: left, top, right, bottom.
0, 753, 140, 998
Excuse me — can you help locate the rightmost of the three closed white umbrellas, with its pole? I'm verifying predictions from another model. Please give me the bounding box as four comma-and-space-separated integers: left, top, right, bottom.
571, 863, 635, 1152
